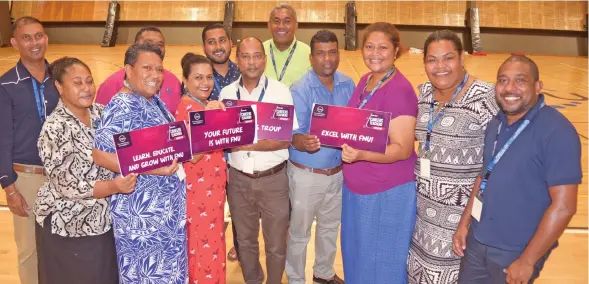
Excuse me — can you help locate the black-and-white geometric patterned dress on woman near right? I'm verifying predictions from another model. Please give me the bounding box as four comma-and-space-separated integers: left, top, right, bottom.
407, 80, 499, 284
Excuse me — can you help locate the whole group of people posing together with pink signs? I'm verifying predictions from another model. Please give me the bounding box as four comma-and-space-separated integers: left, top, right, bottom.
0, 4, 582, 284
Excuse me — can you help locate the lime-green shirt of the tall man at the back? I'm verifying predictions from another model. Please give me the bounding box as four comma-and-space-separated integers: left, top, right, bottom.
264, 37, 311, 87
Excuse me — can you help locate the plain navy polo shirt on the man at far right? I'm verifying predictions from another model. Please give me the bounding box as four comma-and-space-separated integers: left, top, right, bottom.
472, 95, 583, 252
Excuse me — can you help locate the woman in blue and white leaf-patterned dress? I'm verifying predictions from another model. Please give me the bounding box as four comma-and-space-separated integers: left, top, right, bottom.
93, 44, 188, 284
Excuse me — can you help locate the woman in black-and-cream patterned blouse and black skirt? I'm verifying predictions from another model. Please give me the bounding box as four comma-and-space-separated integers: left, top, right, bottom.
34, 57, 136, 284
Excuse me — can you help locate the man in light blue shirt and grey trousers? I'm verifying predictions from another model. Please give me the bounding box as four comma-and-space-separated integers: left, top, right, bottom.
286, 30, 354, 284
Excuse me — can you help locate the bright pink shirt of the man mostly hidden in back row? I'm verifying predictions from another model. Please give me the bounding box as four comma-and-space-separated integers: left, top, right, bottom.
96, 69, 182, 113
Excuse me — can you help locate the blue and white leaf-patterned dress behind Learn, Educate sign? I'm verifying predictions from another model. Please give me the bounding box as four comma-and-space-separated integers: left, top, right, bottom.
94, 93, 188, 284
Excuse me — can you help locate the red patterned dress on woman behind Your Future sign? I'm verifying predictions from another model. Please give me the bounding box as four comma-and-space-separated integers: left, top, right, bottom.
176, 96, 227, 284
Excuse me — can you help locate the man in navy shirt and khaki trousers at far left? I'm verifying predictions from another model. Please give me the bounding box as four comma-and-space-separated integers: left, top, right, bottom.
0, 16, 59, 284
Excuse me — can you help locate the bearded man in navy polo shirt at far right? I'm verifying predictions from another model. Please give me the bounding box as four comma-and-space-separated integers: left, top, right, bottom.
453, 56, 582, 284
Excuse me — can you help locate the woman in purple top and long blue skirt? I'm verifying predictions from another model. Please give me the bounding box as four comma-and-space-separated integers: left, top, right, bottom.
341, 23, 417, 284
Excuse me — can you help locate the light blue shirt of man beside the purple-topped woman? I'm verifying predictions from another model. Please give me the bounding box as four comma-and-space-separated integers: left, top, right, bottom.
289, 69, 355, 169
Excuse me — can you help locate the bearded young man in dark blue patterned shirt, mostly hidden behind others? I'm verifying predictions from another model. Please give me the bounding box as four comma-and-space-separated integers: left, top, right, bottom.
202, 23, 241, 261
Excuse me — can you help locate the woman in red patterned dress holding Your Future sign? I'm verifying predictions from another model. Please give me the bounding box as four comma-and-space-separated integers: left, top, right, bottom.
176, 53, 227, 284
